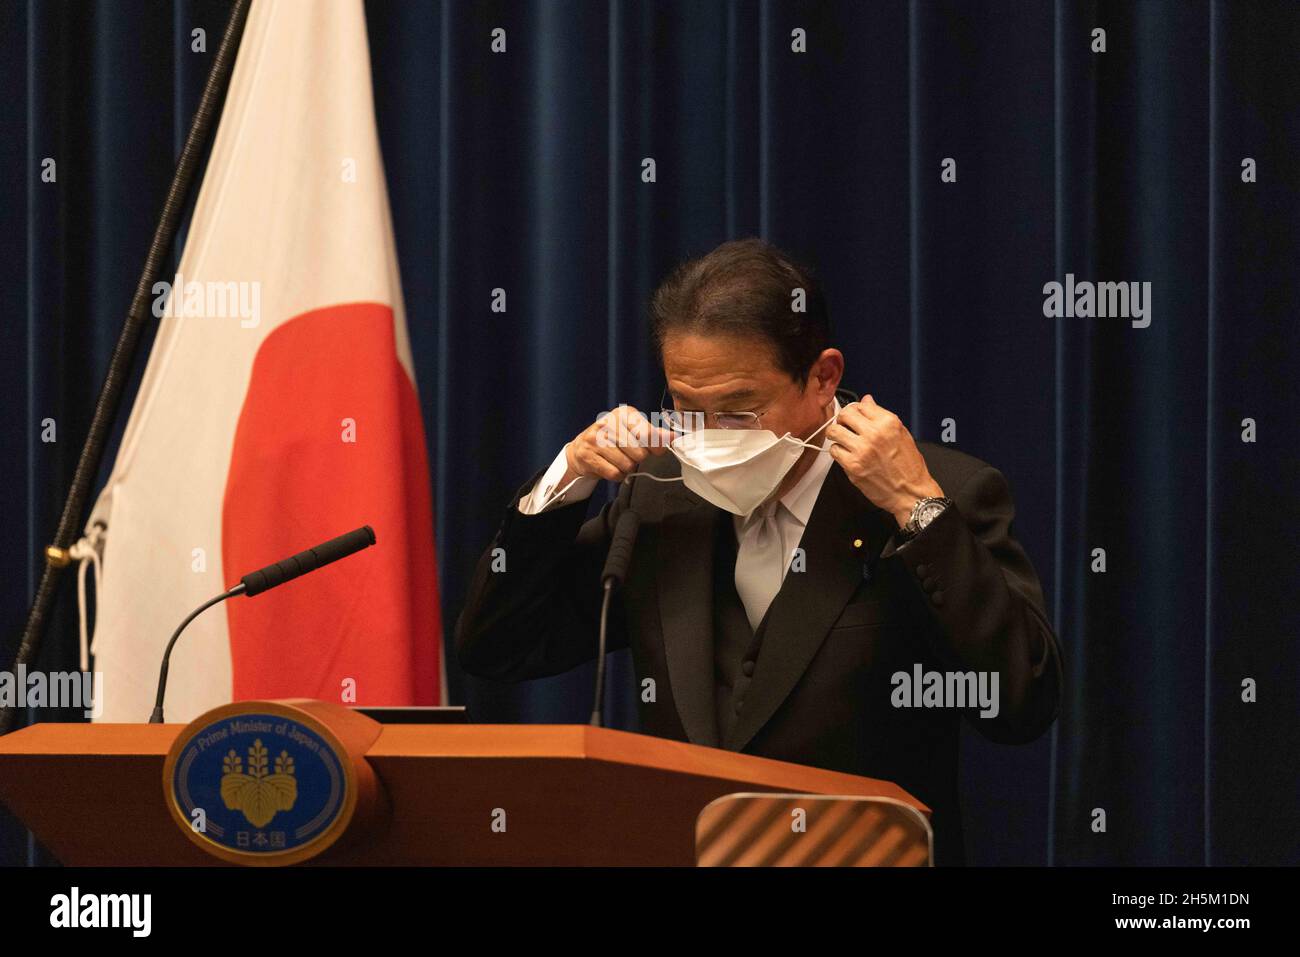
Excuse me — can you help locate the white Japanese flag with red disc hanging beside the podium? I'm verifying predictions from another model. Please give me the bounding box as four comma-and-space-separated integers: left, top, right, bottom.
87, 0, 445, 722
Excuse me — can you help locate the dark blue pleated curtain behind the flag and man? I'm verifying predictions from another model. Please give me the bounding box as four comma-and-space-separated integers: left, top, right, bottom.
0, 0, 1300, 865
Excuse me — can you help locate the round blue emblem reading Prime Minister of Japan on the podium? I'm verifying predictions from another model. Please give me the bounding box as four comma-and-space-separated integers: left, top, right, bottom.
168, 709, 354, 862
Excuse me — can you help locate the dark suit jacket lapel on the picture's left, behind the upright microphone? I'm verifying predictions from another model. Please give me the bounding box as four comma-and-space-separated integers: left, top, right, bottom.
655, 485, 719, 748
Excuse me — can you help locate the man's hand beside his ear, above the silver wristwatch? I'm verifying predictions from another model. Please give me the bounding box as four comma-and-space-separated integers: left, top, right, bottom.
826, 395, 944, 528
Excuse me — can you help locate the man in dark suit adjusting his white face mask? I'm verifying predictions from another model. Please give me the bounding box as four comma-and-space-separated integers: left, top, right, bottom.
455, 239, 1062, 863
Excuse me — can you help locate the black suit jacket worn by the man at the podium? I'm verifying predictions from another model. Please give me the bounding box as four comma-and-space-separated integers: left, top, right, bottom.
455, 399, 1062, 865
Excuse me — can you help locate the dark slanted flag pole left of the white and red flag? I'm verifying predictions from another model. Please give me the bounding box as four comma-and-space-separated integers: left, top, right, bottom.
0, 0, 252, 735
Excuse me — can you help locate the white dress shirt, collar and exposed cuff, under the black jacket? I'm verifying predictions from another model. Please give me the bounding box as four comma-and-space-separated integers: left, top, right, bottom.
519, 399, 840, 628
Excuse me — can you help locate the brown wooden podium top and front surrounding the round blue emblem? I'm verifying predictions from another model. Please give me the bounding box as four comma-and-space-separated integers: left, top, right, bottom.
0, 701, 930, 866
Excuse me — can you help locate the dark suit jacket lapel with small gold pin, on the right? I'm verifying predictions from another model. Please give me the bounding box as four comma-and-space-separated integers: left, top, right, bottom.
722, 465, 894, 752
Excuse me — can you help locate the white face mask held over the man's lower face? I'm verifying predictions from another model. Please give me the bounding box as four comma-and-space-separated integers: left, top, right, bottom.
668, 416, 835, 516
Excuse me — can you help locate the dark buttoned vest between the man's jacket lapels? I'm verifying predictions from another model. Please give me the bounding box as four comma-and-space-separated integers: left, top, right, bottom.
714, 512, 776, 748
